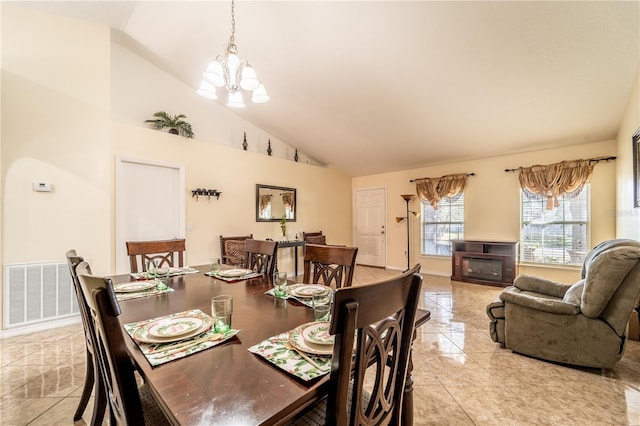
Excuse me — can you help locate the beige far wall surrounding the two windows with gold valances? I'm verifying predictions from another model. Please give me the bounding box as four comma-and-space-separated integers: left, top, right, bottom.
353, 141, 616, 282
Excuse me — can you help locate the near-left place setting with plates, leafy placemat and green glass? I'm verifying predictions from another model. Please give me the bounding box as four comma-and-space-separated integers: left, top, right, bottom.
124, 306, 240, 366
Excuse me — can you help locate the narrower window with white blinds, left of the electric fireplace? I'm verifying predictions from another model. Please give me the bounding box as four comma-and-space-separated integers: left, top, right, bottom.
422, 194, 464, 256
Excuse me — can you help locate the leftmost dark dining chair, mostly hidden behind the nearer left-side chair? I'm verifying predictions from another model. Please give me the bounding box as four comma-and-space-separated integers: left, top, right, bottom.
66, 249, 107, 426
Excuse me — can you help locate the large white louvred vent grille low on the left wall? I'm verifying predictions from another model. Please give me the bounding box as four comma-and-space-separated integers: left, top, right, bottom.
3, 262, 79, 329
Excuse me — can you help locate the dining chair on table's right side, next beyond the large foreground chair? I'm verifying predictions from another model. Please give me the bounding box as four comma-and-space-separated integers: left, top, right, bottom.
302, 244, 358, 289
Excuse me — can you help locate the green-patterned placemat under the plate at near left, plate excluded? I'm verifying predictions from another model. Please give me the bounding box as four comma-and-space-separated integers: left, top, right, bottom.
123, 309, 240, 367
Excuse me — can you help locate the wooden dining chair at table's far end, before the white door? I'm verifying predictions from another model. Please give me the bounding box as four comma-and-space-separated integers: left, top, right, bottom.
126, 238, 186, 273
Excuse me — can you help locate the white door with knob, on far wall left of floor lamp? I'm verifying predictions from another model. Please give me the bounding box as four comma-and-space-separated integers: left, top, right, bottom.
354, 188, 387, 267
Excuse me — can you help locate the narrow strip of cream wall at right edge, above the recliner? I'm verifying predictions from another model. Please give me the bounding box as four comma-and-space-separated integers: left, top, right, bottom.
615, 69, 640, 240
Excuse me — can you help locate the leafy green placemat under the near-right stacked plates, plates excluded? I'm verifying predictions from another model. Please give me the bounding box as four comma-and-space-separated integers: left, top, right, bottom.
248, 332, 331, 381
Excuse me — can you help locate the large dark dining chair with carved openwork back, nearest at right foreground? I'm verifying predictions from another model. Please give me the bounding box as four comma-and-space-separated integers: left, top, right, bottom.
293, 264, 422, 425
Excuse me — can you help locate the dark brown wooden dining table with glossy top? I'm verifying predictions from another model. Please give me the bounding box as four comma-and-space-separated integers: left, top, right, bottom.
111, 266, 429, 425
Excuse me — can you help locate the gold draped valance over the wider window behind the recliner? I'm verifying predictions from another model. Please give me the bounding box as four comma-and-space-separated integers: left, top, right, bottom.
519, 160, 595, 210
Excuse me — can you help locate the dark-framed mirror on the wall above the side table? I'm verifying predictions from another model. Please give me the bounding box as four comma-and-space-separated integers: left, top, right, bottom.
256, 184, 298, 222
